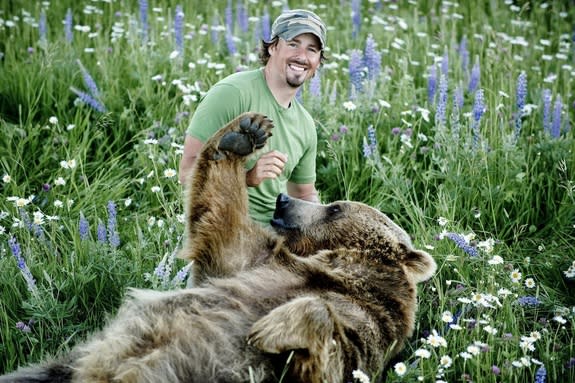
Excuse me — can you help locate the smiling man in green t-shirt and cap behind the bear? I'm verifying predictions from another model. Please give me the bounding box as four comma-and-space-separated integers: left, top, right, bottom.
179, 9, 326, 225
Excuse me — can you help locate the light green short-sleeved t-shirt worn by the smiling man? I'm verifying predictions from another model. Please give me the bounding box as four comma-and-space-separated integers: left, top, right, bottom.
187, 69, 317, 225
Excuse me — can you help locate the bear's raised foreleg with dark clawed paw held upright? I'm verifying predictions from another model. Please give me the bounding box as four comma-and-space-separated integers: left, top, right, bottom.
180, 113, 273, 284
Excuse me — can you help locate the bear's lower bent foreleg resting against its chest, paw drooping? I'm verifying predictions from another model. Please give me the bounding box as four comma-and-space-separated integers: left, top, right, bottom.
248, 296, 344, 383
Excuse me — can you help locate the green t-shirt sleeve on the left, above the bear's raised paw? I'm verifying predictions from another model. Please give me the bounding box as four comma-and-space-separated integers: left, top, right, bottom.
186, 84, 242, 142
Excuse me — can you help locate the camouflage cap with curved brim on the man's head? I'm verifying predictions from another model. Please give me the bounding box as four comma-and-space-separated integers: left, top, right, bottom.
271, 9, 326, 49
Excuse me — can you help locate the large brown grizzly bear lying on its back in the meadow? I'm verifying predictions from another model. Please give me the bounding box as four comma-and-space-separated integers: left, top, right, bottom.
0, 113, 436, 383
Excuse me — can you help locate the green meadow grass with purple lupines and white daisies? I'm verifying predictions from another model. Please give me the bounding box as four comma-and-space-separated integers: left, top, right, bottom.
0, 0, 575, 382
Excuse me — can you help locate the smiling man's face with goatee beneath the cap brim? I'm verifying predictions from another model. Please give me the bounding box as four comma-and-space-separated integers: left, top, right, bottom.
268, 33, 321, 88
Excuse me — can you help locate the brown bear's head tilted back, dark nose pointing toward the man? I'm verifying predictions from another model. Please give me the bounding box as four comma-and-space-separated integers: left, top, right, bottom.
271, 194, 437, 282
